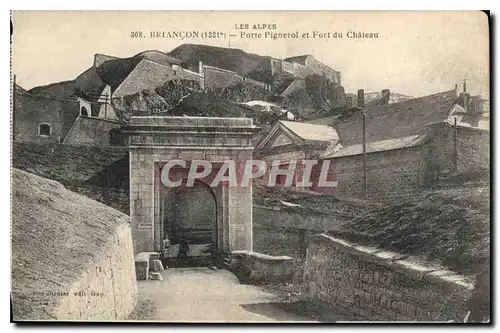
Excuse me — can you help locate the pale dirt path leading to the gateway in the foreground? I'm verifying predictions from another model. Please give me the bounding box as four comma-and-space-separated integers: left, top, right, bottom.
129, 267, 316, 322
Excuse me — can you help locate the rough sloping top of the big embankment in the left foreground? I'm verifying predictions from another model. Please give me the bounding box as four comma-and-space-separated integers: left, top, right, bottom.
11, 169, 129, 320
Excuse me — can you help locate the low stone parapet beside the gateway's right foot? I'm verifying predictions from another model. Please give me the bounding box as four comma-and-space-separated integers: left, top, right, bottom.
229, 251, 294, 284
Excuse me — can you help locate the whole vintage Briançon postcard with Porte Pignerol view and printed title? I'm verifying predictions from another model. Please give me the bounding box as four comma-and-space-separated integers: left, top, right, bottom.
11, 11, 491, 323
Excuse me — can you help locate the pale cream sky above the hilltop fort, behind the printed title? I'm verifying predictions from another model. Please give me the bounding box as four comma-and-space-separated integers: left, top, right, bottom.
12, 11, 489, 98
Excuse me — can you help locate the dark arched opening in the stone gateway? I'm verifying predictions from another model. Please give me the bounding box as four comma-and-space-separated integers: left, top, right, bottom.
162, 182, 218, 266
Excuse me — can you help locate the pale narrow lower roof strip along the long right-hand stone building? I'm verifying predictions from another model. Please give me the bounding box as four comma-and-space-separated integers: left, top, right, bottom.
321, 134, 427, 159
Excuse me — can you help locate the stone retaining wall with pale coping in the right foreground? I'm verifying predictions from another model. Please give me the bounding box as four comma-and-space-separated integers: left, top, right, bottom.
303, 234, 473, 322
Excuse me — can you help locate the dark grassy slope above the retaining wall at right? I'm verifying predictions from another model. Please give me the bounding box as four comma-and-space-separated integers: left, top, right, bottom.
334, 172, 490, 275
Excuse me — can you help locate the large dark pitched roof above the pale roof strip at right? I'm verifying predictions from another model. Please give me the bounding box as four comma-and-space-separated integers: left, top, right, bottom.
334, 90, 458, 146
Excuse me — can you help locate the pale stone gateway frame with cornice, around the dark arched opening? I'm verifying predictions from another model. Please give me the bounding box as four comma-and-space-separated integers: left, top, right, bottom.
122, 116, 258, 253
